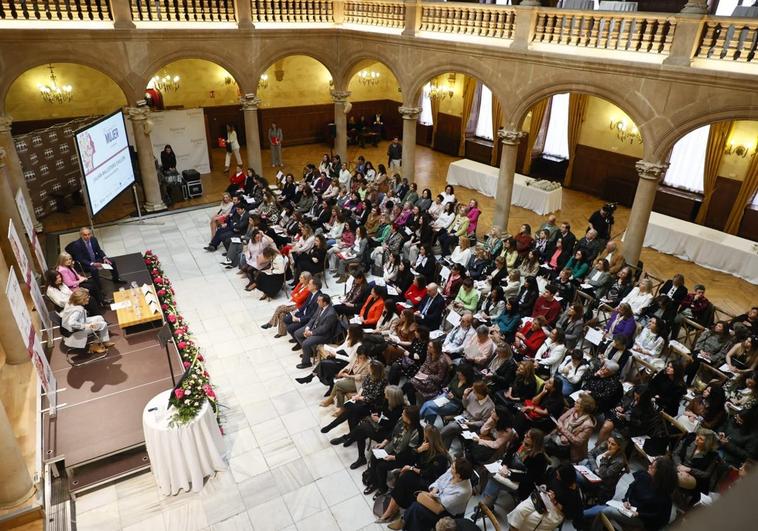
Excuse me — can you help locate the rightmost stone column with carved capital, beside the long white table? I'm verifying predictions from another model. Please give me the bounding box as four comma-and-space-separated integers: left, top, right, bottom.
624, 160, 669, 266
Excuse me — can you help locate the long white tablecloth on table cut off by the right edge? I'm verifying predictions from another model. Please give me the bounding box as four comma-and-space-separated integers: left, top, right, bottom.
643, 212, 758, 284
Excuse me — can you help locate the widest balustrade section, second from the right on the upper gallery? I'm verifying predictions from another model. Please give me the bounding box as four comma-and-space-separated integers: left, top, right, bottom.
532, 9, 676, 55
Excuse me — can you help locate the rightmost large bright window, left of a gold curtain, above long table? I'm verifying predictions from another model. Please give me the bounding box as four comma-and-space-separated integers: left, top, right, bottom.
663, 125, 711, 194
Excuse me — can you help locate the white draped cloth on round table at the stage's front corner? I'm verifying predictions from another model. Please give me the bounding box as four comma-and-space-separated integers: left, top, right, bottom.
142, 390, 227, 496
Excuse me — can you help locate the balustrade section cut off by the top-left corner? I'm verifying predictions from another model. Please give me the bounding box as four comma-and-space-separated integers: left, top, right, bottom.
0, 0, 111, 21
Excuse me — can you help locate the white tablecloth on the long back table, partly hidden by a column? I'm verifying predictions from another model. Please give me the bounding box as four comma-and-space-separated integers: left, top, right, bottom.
447, 159, 563, 214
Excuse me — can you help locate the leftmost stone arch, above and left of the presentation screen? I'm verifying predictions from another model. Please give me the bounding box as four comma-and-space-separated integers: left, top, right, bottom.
0, 53, 136, 110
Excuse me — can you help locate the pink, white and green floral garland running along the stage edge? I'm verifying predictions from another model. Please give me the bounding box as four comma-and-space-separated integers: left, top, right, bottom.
143, 250, 223, 433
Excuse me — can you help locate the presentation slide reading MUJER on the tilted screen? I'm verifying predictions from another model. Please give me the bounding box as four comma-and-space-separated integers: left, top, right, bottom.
76, 111, 134, 216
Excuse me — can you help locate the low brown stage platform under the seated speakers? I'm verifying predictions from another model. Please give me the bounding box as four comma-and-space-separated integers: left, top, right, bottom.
42, 253, 183, 492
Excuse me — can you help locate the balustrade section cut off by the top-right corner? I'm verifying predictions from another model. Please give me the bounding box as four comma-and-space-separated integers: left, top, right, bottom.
695, 17, 758, 64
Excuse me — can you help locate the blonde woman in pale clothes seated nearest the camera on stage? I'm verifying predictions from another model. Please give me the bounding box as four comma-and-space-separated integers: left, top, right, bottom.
61, 288, 113, 354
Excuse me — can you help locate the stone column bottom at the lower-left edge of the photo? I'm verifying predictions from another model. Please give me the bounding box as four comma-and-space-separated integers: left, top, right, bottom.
0, 396, 34, 509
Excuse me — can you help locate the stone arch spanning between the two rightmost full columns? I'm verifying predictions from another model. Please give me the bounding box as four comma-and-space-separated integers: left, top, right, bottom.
505, 81, 657, 159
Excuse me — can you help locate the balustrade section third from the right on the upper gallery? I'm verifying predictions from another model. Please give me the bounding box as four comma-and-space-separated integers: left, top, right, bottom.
419, 2, 516, 39
